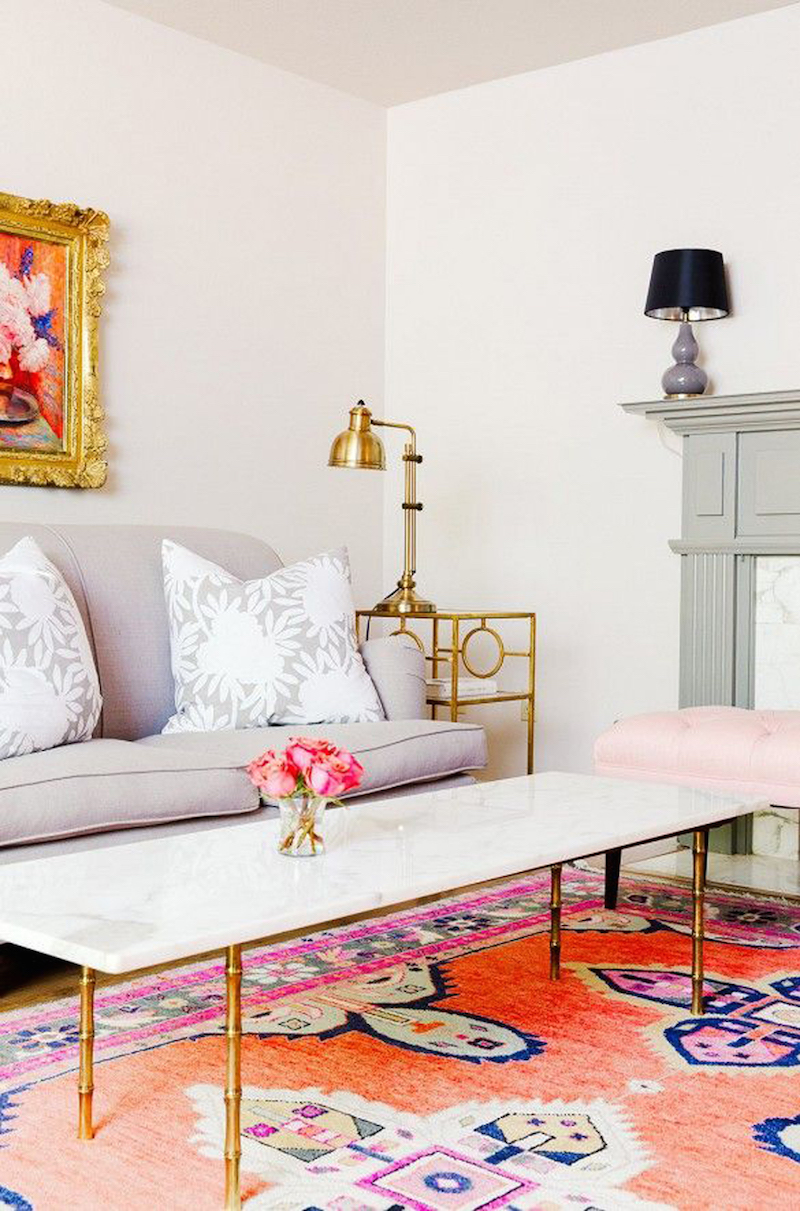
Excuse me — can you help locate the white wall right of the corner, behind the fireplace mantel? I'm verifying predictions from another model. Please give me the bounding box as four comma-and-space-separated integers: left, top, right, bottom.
385, 6, 800, 773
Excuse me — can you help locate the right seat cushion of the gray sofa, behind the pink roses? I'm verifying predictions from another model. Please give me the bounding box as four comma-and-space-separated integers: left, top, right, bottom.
137, 719, 487, 797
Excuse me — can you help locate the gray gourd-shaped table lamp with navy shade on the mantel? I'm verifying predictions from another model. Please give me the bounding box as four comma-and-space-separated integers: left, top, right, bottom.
644, 248, 730, 400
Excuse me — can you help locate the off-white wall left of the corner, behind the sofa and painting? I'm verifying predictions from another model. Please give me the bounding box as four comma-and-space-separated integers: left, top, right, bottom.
0, 0, 386, 599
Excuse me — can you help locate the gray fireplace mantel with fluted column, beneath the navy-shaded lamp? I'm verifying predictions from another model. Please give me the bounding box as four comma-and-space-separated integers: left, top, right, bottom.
621, 390, 800, 849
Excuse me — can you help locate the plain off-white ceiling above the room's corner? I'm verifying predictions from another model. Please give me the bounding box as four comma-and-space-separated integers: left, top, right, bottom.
98, 0, 793, 105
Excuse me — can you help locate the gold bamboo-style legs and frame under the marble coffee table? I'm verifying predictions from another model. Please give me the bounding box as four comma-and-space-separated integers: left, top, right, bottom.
77, 821, 711, 1211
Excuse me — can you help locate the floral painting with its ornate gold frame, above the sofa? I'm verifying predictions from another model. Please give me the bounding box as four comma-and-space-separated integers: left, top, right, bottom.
0, 193, 109, 488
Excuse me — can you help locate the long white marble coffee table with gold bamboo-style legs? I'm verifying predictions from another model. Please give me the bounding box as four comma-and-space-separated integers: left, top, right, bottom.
0, 774, 764, 1211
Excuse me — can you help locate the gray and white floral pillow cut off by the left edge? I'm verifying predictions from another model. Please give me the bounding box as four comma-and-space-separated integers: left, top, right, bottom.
0, 538, 102, 759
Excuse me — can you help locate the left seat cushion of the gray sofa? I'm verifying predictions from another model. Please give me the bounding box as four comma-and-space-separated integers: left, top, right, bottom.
0, 740, 258, 846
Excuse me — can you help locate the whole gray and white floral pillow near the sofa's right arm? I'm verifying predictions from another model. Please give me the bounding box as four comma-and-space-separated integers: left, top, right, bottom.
162, 540, 384, 731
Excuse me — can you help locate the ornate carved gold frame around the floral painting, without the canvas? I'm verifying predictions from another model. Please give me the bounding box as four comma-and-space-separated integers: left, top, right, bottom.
0, 193, 109, 488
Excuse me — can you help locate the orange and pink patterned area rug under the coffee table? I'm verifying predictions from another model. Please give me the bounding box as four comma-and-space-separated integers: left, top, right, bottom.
0, 869, 800, 1211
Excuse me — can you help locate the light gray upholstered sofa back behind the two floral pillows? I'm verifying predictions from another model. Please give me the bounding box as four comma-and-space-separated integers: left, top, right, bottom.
0, 522, 281, 740
